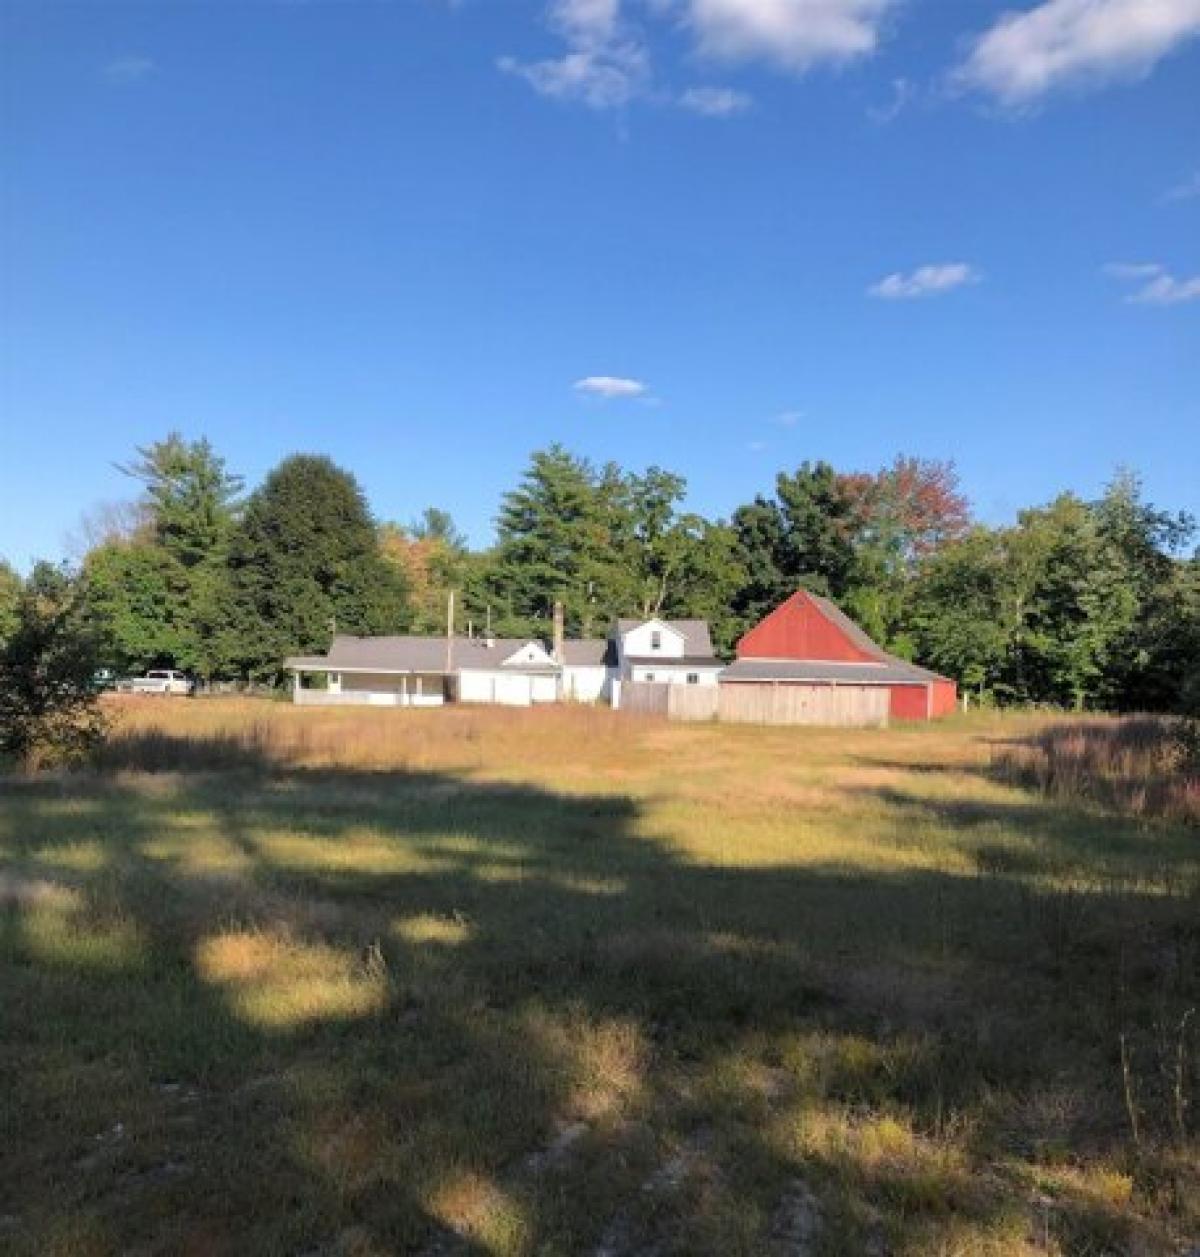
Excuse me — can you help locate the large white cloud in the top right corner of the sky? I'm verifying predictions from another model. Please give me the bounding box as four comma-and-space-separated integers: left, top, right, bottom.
955, 0, 1200, 104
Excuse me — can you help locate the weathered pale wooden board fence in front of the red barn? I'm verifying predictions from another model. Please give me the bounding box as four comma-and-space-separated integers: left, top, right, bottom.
621, 681, 890, 728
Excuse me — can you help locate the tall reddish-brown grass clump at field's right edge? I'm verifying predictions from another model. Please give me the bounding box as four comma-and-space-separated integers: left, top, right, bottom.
993, 715, 1200, 825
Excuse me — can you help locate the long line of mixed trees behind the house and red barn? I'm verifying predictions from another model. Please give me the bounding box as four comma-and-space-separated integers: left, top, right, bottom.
0, 434, 1200, 710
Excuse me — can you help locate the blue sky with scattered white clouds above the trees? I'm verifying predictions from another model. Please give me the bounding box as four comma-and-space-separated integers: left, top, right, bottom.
0, 0, 1200, 567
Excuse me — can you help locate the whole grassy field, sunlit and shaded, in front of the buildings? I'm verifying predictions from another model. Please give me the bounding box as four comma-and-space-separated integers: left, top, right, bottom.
0, 700, 1200, 1257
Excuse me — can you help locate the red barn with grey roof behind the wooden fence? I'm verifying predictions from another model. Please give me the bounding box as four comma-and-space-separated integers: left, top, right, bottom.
721, 590, 957, 720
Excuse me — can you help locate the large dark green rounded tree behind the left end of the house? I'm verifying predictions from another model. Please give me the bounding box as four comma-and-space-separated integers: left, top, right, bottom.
220, 454, 407, 680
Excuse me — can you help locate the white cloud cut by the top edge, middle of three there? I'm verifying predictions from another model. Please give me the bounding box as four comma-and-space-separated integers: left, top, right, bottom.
685, 0, 891, 73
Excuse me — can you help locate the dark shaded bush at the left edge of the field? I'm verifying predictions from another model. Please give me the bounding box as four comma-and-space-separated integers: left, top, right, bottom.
0, 563, 104, 764
